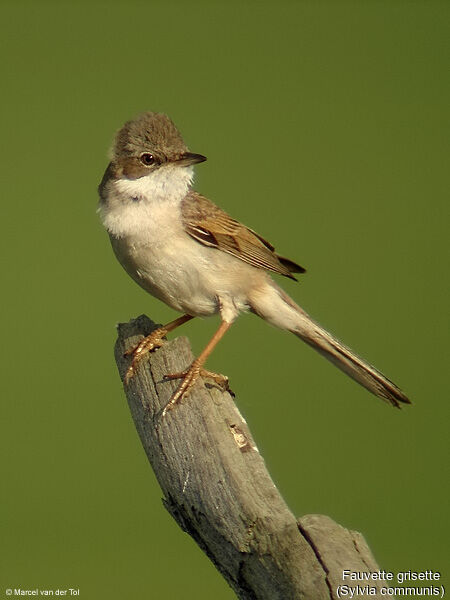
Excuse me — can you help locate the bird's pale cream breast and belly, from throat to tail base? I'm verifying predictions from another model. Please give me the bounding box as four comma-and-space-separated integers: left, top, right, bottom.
99, 170, 266, 320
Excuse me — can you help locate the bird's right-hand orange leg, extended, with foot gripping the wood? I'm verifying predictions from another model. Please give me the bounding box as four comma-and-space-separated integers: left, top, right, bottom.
162, 321, 231, 417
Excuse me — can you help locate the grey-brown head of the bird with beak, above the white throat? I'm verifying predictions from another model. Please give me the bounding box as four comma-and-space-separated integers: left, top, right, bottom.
109, 112, 206, 179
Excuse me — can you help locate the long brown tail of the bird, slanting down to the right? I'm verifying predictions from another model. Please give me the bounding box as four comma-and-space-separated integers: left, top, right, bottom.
250, 281, 411, 408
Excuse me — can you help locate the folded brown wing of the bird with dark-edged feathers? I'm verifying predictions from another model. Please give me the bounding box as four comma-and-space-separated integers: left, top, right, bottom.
181, 191, 305, 280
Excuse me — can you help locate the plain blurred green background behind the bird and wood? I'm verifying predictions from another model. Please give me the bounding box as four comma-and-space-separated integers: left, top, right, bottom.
0, 1, 450, 600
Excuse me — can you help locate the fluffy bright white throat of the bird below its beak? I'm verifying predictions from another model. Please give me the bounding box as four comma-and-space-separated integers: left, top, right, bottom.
98, 165, 194, 238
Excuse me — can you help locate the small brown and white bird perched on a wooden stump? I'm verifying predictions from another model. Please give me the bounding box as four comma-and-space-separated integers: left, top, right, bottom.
98, 112, 410, 416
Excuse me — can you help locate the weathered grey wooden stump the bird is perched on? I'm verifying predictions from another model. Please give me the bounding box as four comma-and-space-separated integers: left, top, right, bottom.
115, 315, 389, 600
